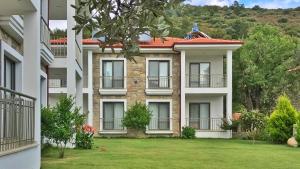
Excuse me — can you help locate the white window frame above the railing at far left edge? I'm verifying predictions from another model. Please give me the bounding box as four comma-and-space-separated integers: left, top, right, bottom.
0, 40, 23, 92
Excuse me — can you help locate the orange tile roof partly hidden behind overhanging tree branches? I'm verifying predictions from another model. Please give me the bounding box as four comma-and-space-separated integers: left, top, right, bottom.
50, 37, 243, 48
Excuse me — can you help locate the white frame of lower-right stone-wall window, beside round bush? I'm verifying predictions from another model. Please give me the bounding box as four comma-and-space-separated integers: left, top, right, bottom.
146, 99, 173, 134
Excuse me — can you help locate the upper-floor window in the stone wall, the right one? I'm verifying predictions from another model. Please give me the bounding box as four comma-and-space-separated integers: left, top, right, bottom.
148, 60, 170, 89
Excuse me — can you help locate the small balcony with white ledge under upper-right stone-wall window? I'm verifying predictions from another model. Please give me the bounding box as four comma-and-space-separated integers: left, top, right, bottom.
145, 76, 173, 95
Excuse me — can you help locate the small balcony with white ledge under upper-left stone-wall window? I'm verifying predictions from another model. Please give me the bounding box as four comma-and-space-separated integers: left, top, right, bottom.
99, 76, 127, 95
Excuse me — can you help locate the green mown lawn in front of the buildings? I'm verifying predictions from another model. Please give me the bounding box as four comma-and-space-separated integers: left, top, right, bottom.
42, 139, 300, 169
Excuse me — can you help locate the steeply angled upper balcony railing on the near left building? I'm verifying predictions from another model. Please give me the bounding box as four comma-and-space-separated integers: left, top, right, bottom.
41, 17, 54, 64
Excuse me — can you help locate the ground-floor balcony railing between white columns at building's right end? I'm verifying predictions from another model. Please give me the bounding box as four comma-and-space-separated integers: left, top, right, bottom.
186, 118, 225, 131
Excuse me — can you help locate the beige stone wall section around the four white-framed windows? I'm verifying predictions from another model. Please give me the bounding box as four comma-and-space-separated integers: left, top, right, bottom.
93, 54, 180, 136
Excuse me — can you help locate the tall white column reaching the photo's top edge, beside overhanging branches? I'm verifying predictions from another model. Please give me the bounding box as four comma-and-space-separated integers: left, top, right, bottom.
67, 0, 77, 97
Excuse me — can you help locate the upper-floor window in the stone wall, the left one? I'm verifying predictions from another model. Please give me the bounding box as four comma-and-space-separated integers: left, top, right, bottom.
102, 60, 124, 89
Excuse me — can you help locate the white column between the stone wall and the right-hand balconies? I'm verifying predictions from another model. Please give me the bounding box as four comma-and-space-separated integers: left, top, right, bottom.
180, 50, 186, 129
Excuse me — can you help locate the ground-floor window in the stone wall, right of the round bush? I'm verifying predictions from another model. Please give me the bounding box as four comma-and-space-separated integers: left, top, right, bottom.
148, 102, 170, 130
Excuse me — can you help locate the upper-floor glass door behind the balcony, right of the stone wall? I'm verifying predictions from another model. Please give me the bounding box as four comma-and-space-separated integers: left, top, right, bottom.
189, 63, 210, 87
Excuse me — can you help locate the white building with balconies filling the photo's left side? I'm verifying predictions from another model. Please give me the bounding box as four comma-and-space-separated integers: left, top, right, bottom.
0, 0, 82, 169
